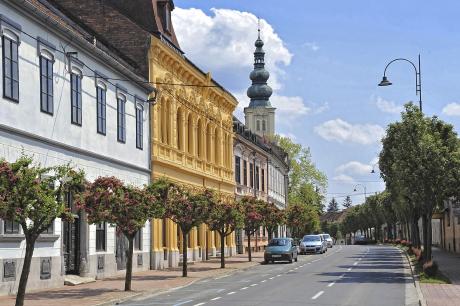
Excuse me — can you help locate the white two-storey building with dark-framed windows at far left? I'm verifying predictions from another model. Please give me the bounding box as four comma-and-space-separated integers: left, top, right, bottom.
0, 0, 153, 294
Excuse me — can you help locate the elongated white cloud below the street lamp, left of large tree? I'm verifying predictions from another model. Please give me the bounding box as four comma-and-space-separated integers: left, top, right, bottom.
314, 118, 385, 145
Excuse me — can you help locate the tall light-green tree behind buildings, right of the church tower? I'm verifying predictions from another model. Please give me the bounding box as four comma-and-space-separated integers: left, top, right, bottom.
275, 136, 327, 213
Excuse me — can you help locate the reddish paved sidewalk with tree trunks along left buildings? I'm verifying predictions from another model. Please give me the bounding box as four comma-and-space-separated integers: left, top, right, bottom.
0, 252, 263, 306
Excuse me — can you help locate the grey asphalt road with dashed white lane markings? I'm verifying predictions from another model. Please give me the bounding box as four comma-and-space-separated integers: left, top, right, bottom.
123, 246, 418, 306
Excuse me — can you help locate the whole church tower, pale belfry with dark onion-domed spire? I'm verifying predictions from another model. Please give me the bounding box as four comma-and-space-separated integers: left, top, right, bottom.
244, 27, 275, 137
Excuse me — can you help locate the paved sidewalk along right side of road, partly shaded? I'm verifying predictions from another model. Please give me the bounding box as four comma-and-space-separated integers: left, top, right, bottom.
420, 247, 460, 306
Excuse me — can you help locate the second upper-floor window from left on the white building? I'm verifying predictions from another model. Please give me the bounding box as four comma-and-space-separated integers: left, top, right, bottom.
40, 56, 53, 115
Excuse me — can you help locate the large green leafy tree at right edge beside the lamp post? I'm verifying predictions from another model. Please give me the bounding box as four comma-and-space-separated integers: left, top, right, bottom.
379, 103, 460, 260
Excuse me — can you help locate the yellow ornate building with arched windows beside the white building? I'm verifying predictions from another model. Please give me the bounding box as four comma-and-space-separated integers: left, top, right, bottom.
149, 1, 238, 268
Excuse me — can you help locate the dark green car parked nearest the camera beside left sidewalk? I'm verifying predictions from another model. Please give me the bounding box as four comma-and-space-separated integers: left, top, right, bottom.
264, 238, 298, 263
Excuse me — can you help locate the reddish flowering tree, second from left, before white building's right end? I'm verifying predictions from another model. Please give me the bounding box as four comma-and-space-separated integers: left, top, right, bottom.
81, 177, 163, 291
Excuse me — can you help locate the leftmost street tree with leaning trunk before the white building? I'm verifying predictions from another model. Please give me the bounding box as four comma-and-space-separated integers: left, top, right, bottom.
0, 156, 84, 306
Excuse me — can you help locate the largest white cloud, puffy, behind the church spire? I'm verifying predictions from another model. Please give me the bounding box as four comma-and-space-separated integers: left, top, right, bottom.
173, 7, 292, 90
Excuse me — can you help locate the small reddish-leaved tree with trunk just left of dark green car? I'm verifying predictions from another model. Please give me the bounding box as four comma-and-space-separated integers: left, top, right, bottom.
238, 196, 265, 261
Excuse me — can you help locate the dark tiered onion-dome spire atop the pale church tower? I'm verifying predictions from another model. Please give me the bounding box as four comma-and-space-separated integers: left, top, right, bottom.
247, 19, 273, 107
